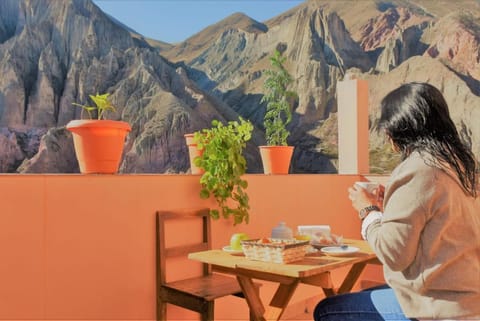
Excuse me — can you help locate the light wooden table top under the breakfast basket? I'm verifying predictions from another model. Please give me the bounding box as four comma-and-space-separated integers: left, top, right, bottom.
188, 239, 376, 278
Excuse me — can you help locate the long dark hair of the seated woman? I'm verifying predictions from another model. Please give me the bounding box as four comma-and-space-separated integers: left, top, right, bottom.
378, 82, 477, 197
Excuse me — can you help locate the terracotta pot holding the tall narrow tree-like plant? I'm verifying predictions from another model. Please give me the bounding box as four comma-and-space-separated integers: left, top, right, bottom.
259, 146, 293, 174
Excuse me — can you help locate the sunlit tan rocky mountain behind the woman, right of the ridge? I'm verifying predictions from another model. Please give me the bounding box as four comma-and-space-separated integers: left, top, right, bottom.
161, 0, 480, 172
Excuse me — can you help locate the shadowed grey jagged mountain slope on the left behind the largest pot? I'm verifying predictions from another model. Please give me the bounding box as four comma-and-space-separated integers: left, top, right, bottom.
0, 0, 258, 173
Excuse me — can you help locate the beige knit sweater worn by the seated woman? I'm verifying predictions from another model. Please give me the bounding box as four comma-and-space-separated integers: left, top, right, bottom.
366, 153, 480, 320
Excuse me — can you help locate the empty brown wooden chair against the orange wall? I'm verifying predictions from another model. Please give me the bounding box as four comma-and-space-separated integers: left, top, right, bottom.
156, 209, 252, 321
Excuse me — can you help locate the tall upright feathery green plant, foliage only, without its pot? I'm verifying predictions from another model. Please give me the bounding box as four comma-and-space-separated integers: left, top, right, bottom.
260, 50, 298, 146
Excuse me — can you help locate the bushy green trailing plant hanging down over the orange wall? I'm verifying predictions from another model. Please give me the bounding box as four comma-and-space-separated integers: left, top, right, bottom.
194, 117, 253, 225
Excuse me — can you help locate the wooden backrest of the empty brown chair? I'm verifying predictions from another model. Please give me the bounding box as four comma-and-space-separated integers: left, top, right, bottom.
156, 208, 212, 285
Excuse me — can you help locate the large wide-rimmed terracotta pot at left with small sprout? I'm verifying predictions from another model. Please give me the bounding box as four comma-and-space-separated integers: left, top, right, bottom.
66, 120, 131, 174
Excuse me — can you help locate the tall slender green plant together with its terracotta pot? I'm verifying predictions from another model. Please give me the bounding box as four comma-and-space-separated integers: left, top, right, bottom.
259, 50, 298, 174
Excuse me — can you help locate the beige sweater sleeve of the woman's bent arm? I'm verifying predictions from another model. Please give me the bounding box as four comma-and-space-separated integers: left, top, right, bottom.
365, 158, 435, 271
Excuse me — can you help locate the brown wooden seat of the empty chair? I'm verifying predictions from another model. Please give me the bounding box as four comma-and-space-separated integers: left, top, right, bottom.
163, 274, 243, 301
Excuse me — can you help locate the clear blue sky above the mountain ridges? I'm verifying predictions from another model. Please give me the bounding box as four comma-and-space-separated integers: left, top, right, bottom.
93, 0, 303, 43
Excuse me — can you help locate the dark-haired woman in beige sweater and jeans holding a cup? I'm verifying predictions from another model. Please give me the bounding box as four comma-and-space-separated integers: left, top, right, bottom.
314, 83, 480, 321
